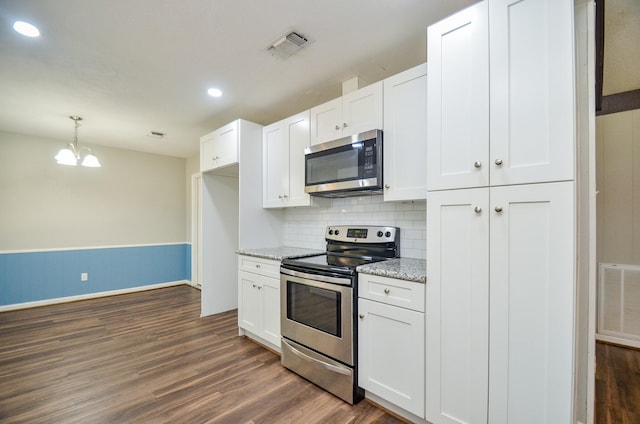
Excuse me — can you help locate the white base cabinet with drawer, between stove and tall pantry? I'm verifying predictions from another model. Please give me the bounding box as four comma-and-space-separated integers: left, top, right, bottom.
358, 274, 425, 418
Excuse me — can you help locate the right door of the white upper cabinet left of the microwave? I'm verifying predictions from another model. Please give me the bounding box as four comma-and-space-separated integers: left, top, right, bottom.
284, 111, 311, 206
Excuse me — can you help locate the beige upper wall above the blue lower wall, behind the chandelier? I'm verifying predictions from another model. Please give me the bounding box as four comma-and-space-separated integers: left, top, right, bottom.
0, 132, 187, 251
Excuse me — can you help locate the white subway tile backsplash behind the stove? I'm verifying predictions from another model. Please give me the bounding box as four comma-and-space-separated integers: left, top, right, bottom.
284, 196, 427, 259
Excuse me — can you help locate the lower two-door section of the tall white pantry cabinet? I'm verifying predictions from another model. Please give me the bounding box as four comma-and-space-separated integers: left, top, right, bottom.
426, 181, 575, 424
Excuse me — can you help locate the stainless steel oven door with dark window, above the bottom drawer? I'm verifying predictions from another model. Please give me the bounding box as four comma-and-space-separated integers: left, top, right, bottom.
280, 268, 355, 366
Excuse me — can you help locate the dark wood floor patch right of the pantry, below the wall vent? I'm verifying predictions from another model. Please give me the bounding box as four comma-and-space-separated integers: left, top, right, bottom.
595, 343, 640, 424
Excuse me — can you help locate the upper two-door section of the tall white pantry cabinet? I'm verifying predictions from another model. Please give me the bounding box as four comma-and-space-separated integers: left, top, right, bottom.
427, 0, 575, 190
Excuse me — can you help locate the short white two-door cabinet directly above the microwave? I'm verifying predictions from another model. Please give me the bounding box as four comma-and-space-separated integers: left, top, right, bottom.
311, 81, 383, 144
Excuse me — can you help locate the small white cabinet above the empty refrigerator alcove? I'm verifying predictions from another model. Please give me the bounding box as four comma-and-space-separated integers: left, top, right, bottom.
200, 120, 239, 172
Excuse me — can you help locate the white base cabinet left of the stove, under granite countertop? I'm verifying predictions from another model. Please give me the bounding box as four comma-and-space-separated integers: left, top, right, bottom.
238, 256, 280, 352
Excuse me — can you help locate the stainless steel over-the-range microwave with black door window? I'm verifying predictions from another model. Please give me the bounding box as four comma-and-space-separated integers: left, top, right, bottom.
304, 130, 382, 197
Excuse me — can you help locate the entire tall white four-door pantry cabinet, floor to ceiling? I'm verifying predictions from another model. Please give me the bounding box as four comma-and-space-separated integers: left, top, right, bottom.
426, 0, 576, 424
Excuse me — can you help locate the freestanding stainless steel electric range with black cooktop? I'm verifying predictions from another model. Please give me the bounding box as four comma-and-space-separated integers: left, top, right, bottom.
280, 225, 400, 404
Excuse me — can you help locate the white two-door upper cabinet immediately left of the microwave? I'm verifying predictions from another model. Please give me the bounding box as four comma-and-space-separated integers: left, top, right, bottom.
262, 111, 311, 208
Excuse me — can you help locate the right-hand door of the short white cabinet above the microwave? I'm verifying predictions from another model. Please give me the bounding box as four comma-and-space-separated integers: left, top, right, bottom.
338, 81, 384, 137
